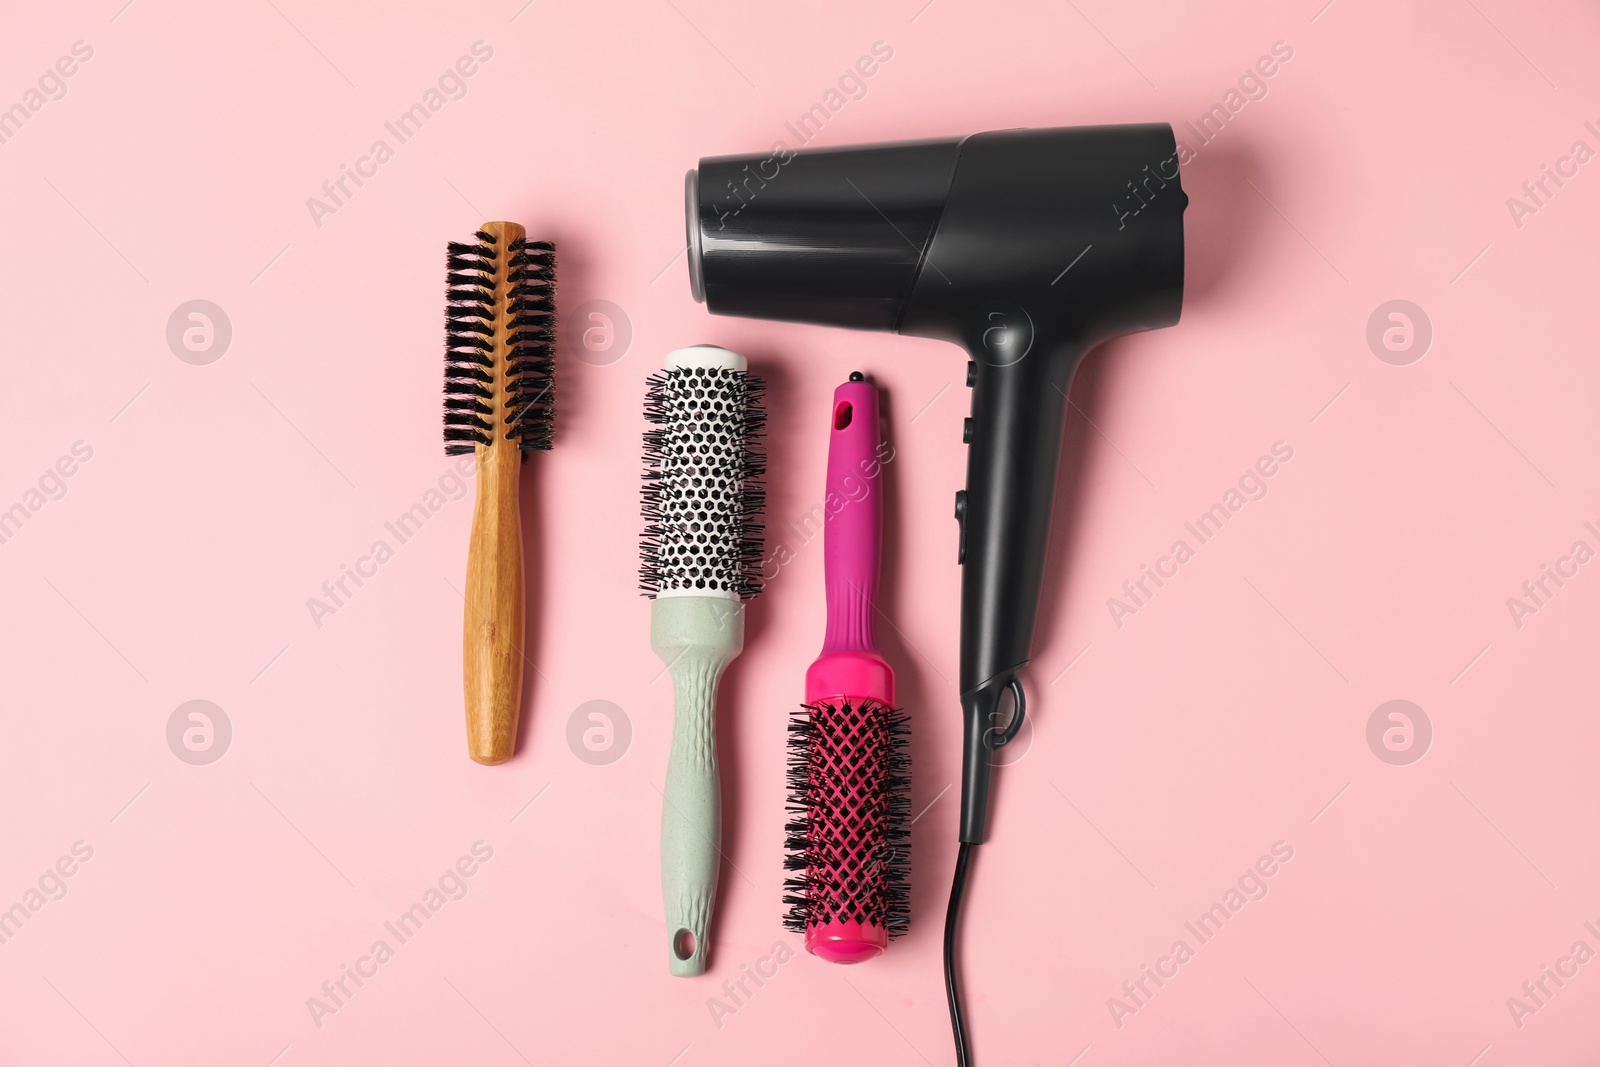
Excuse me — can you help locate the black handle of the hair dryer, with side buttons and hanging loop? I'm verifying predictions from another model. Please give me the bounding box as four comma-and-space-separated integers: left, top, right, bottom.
957, 342, 1082, 845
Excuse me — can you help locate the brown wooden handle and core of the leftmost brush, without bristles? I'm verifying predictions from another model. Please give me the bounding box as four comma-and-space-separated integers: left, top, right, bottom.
461, 222, 526, 765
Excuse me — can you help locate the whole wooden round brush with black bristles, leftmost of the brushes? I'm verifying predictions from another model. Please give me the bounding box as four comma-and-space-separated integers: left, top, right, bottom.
445, 222, 555, 765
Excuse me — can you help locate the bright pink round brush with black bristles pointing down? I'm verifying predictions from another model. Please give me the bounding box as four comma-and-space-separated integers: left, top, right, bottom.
784, 373, 910, 963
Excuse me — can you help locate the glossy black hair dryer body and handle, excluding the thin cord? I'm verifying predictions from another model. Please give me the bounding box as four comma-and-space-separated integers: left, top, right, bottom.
686, 123, 1187, 845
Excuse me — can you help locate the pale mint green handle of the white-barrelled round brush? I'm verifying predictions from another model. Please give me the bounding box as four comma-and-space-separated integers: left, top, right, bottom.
650, 593, 744, 977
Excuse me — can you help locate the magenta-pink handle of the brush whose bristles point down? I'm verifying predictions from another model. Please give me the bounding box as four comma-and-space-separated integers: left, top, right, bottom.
806, 379, 894, 705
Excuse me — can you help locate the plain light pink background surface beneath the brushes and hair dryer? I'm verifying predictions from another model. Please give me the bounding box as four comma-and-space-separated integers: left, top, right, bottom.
0, 0, 1600, 1067
